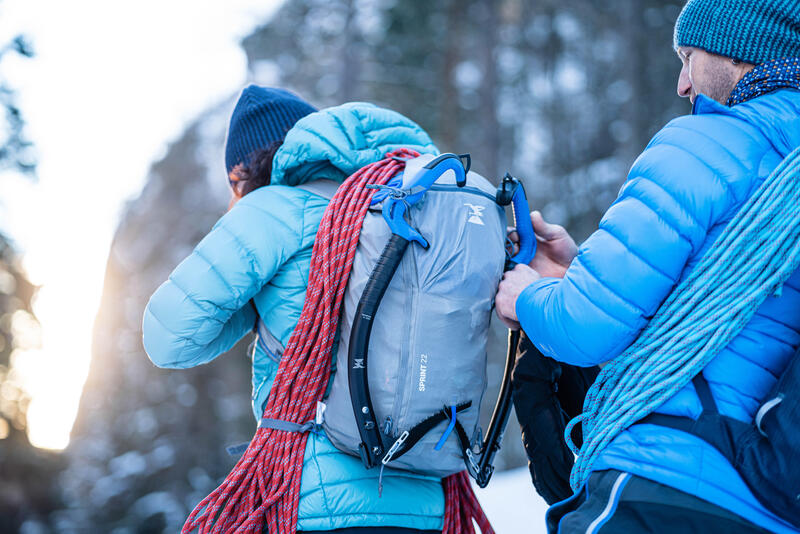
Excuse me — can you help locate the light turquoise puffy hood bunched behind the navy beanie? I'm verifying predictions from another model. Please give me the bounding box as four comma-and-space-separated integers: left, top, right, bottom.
271, 102, 439, 186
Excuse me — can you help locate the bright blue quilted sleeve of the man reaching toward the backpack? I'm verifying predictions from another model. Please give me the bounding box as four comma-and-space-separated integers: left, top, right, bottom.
516, 118, 741, 366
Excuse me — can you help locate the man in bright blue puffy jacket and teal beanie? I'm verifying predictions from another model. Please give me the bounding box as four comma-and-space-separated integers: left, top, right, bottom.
496, 0, 800, 533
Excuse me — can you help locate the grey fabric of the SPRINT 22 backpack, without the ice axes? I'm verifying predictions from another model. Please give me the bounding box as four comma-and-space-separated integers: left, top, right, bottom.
323, 155, 506, 477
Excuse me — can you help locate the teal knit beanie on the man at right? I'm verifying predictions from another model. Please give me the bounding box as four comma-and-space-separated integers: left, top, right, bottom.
674, 0, 800, 65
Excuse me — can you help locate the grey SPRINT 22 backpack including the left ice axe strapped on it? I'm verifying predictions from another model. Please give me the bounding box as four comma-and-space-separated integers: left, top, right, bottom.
258, 154, 532, 485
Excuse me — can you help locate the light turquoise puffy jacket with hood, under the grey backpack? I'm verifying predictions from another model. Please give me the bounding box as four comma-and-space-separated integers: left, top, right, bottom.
142, 103, 444, 531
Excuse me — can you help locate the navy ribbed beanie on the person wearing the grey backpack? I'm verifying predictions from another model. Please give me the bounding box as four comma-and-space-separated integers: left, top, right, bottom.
225, 85, 317, 174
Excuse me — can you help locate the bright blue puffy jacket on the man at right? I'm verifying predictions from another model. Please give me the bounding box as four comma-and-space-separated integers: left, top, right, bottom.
516, 90, 800, 532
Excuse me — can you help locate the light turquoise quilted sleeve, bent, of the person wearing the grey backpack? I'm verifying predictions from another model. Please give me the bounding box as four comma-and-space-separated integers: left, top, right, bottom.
142, 188, 303, 368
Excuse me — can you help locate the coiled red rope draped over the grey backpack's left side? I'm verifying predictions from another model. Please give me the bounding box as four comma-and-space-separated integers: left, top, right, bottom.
181, 149, 494, 534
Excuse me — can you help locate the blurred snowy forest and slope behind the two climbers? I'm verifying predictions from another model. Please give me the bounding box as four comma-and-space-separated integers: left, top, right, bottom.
0, 0, 689, 534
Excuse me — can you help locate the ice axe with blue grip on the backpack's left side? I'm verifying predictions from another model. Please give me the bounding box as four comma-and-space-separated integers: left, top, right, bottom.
347, 154, 469, 469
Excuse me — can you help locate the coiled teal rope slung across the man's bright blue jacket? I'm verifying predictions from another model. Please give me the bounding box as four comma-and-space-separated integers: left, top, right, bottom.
565, 148, 800, 491
